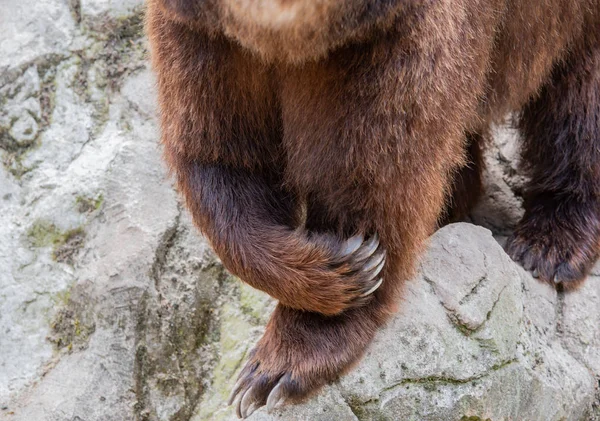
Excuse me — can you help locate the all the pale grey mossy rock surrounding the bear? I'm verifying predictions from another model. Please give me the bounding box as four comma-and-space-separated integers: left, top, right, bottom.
0, 0, 600, 421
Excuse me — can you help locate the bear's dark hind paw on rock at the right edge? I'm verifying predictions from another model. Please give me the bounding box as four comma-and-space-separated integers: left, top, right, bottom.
506, 197, 600, 289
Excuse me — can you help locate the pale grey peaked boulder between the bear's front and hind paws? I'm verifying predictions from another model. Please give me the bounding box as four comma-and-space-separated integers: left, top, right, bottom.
205, 224, 597, 421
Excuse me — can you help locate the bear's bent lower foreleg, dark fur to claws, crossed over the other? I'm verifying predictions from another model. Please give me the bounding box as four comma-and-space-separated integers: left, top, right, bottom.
179, 163, 385, 315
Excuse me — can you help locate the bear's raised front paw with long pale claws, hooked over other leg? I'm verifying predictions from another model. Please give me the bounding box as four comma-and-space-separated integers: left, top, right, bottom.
246, 233, 386, 316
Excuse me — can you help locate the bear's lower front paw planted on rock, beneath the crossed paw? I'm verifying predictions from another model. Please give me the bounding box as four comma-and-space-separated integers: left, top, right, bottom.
229, 304, 381, 418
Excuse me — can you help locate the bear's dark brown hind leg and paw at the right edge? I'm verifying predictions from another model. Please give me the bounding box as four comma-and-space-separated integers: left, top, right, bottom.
506, 42, 600, 289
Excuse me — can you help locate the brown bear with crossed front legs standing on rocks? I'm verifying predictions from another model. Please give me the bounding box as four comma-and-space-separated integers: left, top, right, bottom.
147, 0, 600, 417
